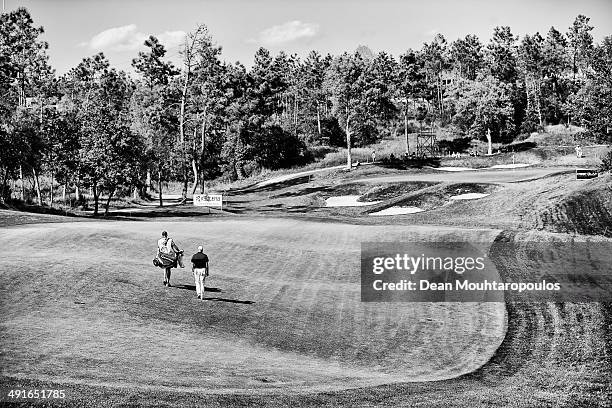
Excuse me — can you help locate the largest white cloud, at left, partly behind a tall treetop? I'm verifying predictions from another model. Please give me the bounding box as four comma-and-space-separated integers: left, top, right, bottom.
80, 24, 185, 51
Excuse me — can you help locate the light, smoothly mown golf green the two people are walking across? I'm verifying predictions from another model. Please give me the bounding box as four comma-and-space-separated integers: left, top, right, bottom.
0, 218, 506, 395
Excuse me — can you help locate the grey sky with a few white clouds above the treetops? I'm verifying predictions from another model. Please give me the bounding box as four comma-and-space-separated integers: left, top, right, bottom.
4, 0, 612, 74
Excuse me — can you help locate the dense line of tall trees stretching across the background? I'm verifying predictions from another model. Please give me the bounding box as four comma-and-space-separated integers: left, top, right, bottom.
0, 8, 612, 214
